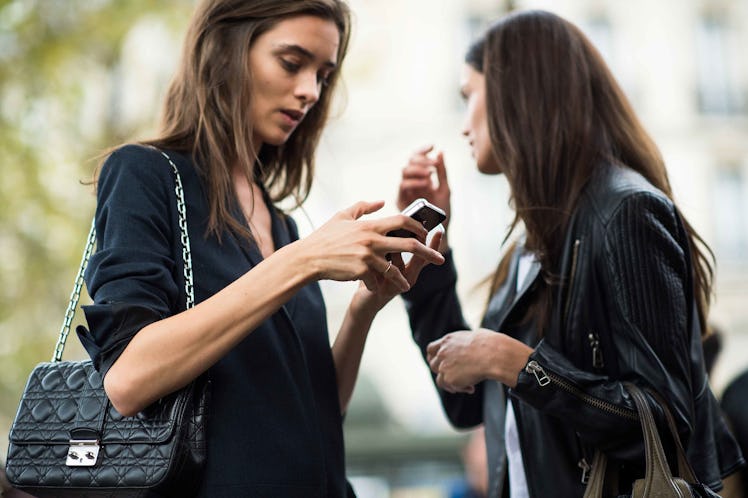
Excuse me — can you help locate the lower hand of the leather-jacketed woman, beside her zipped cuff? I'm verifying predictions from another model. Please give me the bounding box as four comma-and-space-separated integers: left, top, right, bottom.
426, 329, 533, 393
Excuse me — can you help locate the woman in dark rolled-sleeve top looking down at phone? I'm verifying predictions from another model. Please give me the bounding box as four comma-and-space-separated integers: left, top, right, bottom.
82, 0, 443, 498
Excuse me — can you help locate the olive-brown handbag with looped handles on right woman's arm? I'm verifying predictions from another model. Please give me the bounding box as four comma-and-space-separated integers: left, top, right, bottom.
584, 382, 719, 498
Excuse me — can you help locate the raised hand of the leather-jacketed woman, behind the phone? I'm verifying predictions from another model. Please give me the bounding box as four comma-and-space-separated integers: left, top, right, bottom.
397, 145, 450, 229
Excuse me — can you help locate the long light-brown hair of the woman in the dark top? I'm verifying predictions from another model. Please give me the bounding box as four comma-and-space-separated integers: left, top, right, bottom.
144, 0, 351, 241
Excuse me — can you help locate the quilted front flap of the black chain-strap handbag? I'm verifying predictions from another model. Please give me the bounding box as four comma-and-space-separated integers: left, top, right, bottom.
9, 361, 179, 444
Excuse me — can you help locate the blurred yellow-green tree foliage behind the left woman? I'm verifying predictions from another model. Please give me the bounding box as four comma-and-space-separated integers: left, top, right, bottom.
0, 0, 193, 454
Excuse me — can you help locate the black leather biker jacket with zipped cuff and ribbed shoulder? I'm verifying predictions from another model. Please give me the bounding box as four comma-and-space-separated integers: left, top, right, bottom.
404, 161, 744, 498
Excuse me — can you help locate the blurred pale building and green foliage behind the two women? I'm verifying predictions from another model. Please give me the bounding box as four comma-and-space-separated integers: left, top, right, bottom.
0, 0, 748, 498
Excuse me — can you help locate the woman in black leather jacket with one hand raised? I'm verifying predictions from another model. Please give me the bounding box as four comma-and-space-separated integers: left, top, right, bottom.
398, 11, 744, 498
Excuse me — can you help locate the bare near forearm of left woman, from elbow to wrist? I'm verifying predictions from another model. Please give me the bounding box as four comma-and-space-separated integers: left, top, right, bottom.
104, 244, 314, 414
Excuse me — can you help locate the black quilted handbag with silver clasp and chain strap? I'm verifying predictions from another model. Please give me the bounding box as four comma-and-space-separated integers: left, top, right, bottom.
6, 152, 209, 498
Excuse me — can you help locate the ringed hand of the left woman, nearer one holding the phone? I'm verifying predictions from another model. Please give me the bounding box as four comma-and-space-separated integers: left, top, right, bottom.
299, 201, 444, 292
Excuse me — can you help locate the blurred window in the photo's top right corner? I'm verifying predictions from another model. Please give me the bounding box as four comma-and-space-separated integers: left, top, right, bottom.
696, 14, 743, 115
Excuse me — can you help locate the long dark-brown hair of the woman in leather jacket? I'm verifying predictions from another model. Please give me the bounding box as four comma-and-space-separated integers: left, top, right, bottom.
474, 11, 713, 334
